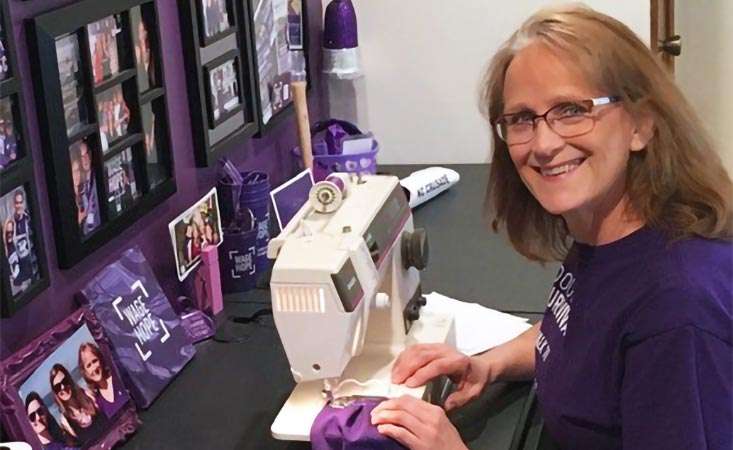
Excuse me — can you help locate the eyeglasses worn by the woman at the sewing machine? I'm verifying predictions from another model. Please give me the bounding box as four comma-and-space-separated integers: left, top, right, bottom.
493, 96, 621, 145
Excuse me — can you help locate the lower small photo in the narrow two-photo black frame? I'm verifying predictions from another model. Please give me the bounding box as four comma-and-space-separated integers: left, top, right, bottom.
204, 53, 242, 128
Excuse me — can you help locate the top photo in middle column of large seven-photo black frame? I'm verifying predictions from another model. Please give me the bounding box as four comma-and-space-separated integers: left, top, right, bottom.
87, 16, 122, 84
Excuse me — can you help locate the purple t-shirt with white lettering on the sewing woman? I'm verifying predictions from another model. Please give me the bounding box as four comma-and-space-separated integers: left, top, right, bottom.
535, 228, 733, 450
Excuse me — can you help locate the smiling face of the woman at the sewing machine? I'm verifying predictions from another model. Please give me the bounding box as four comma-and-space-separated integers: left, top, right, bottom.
503, 43, 647, 220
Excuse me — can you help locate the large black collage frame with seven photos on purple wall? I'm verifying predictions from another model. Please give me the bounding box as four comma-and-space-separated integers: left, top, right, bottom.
29, 0, 176, 269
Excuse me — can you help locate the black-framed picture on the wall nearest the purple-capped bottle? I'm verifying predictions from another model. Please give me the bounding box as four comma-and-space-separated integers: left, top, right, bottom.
238, 0, 310, 136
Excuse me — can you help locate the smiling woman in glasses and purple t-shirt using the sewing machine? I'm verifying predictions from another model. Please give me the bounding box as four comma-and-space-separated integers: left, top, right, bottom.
372, 6, 733, 450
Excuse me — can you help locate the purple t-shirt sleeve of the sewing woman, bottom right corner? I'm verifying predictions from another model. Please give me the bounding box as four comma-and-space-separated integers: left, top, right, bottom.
621, 325, 733, 450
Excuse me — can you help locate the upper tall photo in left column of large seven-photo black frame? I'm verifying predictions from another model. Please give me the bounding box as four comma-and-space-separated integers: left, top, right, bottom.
56, 34, 87, 136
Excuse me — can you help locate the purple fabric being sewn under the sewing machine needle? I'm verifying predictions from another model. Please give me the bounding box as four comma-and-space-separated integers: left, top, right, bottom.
310, 399, 405, 450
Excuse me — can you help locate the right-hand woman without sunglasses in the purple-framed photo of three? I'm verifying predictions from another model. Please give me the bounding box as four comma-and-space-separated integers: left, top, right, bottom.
79, 342, 127, 419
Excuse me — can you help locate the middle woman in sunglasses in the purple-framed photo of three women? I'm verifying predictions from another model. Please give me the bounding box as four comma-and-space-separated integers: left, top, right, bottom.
49, 364, 107, 445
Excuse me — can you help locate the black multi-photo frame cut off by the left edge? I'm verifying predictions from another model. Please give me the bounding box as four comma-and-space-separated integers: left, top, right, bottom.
0, 2, 49, 318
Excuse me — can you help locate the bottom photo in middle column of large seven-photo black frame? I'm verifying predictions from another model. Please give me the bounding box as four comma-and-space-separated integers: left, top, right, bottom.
104, 148, 140, 218
